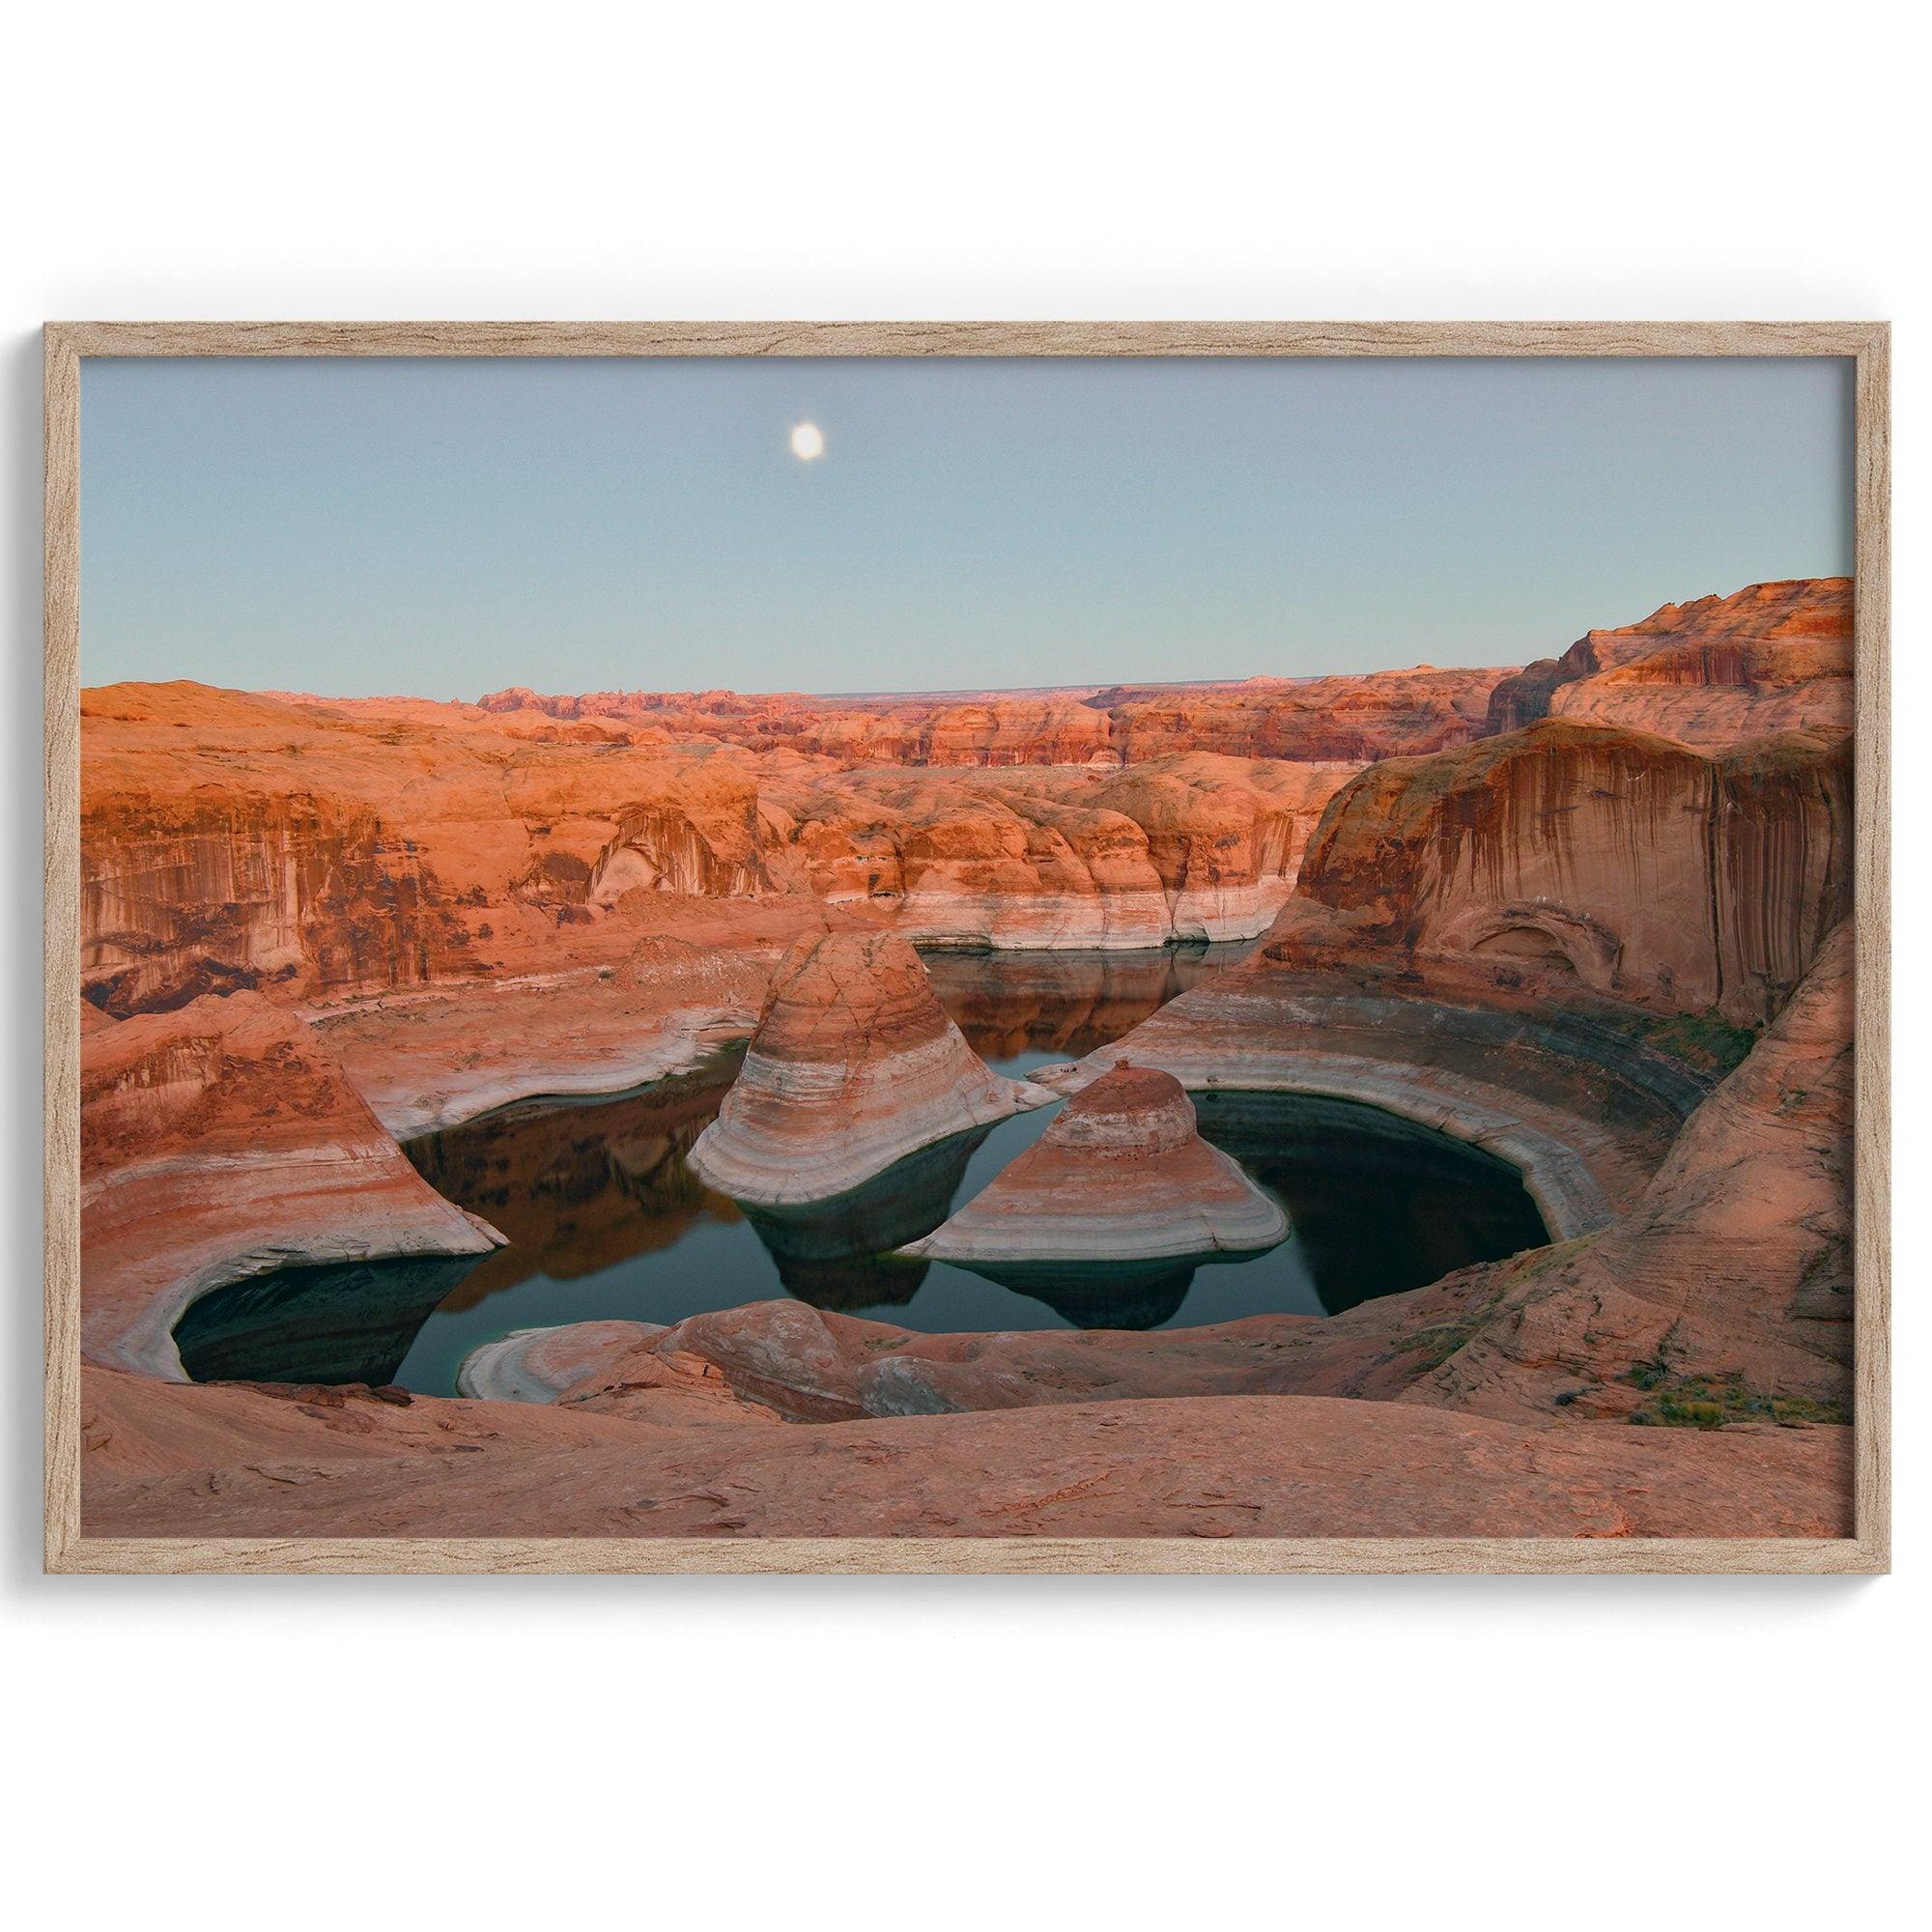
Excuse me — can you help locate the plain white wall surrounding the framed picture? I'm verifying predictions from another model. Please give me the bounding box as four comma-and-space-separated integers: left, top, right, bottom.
0, 0, 1932, 1926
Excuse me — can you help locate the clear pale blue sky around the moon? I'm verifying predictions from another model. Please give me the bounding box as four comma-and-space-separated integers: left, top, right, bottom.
81, 357, 1853, 697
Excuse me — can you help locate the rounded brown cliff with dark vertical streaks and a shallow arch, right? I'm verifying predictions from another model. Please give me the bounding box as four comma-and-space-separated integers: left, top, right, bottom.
1298, 719, 1853, 1024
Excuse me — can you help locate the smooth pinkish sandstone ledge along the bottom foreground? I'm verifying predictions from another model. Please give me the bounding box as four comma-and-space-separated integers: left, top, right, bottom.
81, 1370, 1851, 1538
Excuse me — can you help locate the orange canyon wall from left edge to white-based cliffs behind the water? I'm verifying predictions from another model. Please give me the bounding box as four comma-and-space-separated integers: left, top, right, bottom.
81, 684, 1356, 1016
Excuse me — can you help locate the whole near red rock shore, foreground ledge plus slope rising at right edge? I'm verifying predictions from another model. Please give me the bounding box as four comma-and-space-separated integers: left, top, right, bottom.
71, 933, 1851, 1536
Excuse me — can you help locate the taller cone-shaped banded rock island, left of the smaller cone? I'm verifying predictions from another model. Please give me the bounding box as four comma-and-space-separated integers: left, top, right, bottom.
690, 933, 1053, 1208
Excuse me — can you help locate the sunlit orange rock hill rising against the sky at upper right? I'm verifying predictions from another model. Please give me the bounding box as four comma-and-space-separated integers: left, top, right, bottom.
1488, 578, 1853, 746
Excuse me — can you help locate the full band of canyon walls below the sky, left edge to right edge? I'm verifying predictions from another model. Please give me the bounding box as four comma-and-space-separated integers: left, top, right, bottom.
81, 580, 1851, 1016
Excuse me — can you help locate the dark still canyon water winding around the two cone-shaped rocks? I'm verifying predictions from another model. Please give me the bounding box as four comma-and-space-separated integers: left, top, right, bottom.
176, 947, 1548, 1395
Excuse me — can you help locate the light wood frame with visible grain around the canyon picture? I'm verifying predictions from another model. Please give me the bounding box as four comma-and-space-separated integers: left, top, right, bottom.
44, 321, 1891, 1573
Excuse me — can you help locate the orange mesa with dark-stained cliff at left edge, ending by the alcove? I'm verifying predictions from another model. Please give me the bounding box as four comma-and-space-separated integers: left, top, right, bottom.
81, 684, 777, 1012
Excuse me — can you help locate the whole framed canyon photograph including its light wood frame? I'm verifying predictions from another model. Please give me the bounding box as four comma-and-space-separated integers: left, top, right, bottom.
46, 323, 1889, 1573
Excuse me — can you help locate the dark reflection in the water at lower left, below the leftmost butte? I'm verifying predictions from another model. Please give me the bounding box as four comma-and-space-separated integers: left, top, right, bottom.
174, 1254, 477, 1387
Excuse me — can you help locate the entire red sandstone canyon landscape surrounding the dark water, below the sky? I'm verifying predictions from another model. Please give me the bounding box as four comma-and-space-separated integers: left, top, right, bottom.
79, 580, 1853, 1538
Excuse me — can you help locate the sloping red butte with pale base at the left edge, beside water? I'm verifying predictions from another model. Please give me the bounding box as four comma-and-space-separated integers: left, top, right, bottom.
81, 993, 502, 1379
